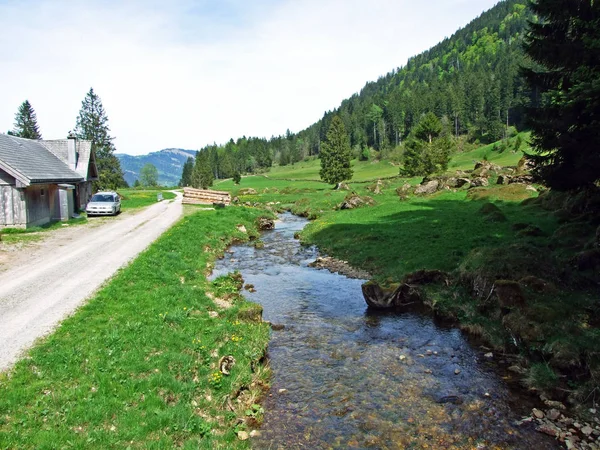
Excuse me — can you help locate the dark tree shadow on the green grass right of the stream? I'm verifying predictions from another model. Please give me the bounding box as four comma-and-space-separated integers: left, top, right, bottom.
311, 199, 552, 280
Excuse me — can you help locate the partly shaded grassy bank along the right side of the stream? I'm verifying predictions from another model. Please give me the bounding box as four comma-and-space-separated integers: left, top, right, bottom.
219, 146, 600, 408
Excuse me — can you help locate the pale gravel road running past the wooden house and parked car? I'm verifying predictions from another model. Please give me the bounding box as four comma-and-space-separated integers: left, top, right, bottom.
0, 194, 182, 371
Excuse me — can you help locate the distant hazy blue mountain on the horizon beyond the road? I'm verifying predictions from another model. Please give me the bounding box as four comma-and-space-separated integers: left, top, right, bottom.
116, 148, 196, 186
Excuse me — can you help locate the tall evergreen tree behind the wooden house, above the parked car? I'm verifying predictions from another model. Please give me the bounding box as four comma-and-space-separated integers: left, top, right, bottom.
75, 88, 127, 190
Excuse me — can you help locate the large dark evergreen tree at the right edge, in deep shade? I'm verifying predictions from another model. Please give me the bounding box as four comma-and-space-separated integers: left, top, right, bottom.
523, 0, 600, 190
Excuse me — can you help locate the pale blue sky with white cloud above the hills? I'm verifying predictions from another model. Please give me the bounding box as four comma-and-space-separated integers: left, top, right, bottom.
0, 0, 497, 154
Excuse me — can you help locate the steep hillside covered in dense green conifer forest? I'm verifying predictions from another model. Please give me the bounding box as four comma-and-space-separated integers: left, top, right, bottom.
186, 0, 533, 183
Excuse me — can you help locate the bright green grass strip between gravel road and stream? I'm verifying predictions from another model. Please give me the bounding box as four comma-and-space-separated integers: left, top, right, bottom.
0, 207, 270, 449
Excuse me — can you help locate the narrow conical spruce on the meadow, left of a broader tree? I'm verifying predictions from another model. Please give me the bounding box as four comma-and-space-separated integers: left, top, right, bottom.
319, 116, 352, 184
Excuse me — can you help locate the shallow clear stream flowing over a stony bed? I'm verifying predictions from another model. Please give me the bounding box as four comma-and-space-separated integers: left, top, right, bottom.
214, 214, 559, 450
